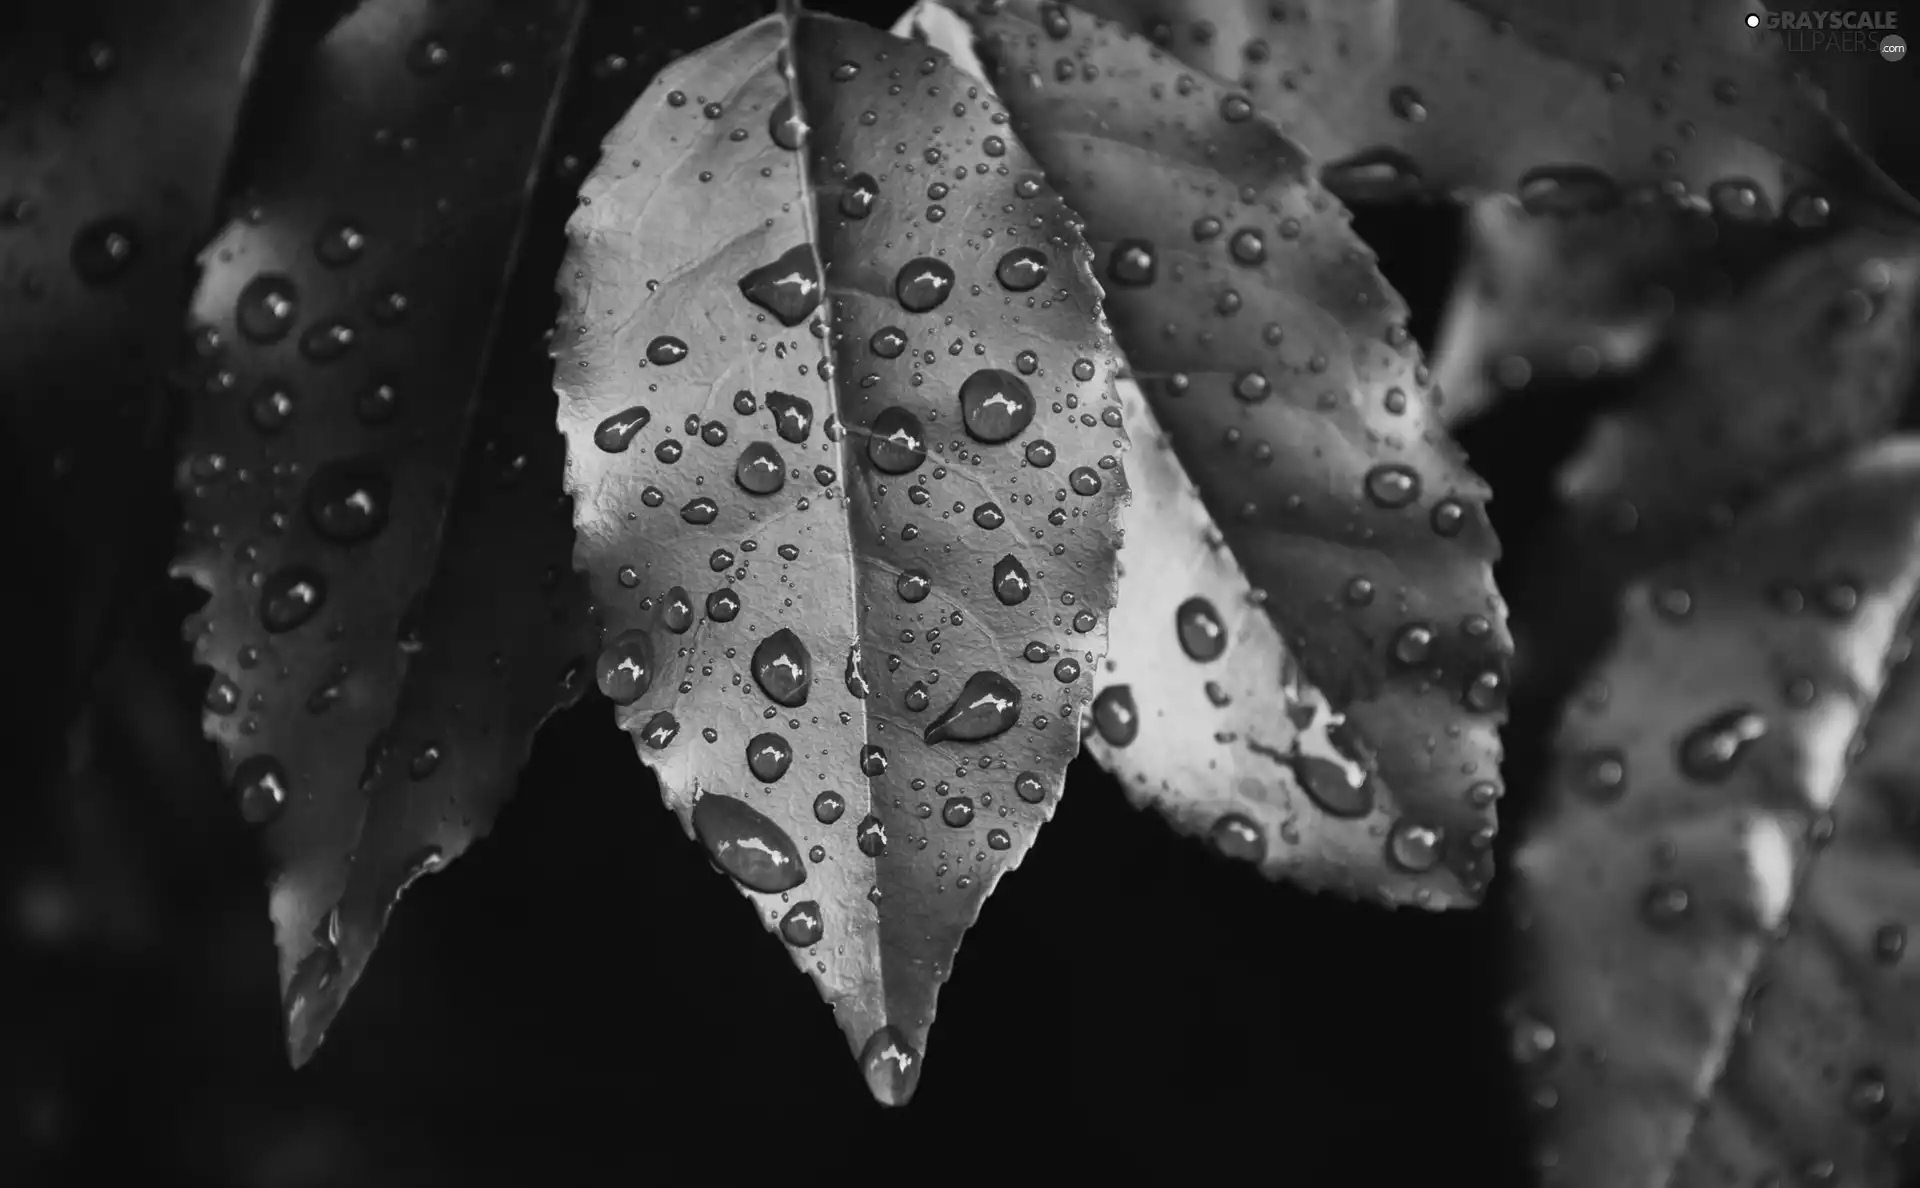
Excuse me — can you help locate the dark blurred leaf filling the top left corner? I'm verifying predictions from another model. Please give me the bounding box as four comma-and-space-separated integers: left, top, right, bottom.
0, 0, 273, 729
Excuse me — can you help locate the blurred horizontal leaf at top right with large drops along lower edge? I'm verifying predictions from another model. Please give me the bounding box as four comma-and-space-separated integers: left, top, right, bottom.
1052, 0, 1920, 219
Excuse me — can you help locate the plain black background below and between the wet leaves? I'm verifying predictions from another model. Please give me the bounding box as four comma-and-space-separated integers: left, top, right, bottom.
0, 0, 1920, 1188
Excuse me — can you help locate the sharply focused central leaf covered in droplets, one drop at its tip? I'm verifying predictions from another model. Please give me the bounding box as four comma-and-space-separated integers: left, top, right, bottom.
555, 15, 1127, 1104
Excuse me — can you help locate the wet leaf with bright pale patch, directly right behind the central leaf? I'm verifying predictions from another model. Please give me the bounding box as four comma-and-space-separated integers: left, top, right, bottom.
952, 0, 1509, 908
